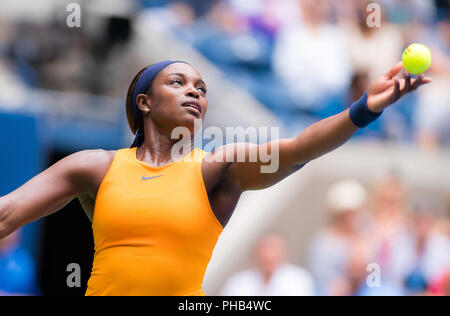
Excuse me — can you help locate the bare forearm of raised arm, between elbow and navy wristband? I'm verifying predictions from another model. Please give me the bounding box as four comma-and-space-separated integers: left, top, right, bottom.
292, 109, 358, 164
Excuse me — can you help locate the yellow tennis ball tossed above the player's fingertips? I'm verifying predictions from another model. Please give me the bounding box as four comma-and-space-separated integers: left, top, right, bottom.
402, 43, 431, 75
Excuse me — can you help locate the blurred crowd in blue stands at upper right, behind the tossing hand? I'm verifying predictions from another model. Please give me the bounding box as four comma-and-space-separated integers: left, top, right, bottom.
144, 0, 450, 149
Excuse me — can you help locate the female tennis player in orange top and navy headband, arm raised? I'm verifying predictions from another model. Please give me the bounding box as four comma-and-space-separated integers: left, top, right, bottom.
0, 61, 431, 296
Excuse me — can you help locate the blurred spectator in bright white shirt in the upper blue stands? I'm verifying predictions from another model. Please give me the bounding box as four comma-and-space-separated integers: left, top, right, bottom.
273, 0, 352, 115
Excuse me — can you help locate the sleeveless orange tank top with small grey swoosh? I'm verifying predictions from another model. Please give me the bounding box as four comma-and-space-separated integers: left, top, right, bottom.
86, 147, 222, 295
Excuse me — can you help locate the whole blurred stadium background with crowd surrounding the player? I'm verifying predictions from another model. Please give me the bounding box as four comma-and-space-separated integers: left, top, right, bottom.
0, 0, 450, 295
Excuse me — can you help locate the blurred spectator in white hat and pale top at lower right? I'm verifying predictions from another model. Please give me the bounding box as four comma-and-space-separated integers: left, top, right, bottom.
309, 180, 366, 295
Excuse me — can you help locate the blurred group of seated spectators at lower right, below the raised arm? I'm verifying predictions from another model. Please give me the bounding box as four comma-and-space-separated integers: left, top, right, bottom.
221, 173, 450, 296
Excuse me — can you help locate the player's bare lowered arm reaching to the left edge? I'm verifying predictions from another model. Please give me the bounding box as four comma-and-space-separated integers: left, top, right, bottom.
0, 150, 111, 239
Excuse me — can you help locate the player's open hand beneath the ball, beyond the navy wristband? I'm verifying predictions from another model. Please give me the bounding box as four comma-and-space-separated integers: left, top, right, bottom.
367, 62, 431, 113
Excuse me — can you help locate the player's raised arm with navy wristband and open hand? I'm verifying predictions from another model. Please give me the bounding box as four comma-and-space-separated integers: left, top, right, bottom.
204, 63, 431, 191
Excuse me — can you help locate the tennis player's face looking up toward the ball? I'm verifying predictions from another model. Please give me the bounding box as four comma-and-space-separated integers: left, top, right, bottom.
144, 63, 208, 133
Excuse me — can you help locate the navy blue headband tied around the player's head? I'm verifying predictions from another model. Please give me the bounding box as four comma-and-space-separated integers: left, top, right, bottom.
130, 60, 187, 148
